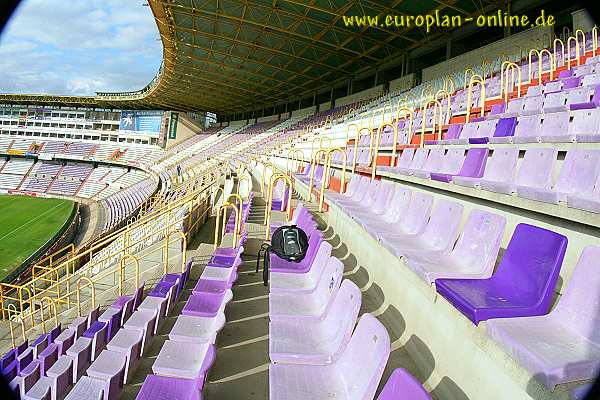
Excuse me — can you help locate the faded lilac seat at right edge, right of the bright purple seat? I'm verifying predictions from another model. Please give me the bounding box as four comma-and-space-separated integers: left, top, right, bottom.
486, 246, 600, 390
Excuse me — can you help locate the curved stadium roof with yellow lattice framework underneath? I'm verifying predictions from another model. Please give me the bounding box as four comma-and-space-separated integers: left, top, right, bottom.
0, 0, 505, 114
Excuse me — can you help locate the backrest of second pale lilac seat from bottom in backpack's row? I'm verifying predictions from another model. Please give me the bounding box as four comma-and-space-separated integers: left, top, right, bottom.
321, 278, 362, 356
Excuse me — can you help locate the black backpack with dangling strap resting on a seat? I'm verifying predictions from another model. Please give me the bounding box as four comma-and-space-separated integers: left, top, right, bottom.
256, 225, 308, 286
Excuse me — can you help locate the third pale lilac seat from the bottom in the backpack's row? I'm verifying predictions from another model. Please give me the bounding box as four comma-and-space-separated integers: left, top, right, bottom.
269, 257, 344, 321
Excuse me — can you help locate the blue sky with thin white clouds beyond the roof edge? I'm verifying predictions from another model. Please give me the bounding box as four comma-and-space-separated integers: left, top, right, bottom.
0, 0, 162, 95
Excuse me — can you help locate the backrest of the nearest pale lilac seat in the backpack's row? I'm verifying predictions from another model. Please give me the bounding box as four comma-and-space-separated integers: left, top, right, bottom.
334, 313, 390, 399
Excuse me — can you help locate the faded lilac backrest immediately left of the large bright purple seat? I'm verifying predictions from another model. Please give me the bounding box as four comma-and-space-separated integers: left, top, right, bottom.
452, 209, 506, 275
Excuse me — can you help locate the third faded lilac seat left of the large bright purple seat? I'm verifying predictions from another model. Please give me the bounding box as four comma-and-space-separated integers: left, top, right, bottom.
364, 187, 433, 242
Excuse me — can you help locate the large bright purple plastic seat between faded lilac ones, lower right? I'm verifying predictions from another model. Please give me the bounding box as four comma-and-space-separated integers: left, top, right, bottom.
435, 224, 567, 325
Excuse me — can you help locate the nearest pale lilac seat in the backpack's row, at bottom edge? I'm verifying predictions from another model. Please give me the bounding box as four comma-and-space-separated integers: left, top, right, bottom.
269, 314, 390, 400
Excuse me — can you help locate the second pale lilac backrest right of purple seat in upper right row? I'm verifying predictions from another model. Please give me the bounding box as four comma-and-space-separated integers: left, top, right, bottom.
516, 148, 558, 189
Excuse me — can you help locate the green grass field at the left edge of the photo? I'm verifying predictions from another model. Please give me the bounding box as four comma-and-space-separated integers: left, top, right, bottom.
0, 196, 75, 280
